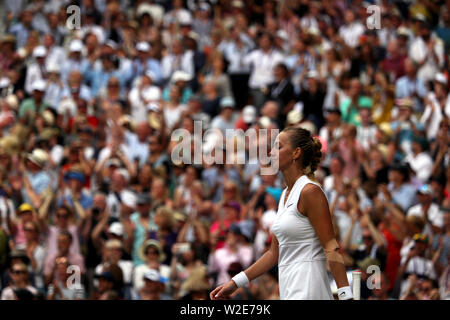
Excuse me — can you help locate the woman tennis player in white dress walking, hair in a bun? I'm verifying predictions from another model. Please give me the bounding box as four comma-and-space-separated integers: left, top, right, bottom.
210, 127, 353, 300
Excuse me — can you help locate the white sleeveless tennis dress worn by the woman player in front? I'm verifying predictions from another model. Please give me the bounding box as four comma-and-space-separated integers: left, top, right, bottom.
271, 175, 333, 300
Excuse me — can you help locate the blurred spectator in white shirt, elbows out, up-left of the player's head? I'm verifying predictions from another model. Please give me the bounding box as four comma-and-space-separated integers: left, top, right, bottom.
244, 33, 284, 108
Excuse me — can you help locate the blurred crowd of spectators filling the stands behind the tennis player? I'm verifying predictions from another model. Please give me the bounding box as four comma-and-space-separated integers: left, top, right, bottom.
0, 0, 450, 300
